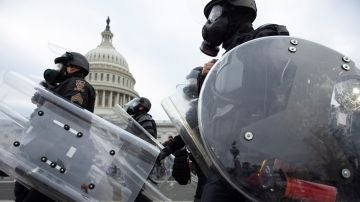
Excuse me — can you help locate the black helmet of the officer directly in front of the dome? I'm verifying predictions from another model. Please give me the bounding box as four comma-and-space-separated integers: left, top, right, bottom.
54, 52, 89, 76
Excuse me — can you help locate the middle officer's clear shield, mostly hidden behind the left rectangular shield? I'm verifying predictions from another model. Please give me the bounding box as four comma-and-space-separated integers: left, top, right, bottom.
103, 105, 174, 201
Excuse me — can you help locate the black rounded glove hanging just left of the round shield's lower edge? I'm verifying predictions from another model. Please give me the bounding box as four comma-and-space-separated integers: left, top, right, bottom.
172, 149, 190, 185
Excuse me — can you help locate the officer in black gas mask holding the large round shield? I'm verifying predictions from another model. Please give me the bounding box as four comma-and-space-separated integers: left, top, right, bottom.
158, 0, 289, 201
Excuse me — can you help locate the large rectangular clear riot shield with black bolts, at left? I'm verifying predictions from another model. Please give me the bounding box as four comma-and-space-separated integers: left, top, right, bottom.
0, 72, 159, 201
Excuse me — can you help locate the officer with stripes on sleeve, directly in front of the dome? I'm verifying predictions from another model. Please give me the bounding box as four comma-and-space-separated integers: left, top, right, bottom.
14, 52, 96, 201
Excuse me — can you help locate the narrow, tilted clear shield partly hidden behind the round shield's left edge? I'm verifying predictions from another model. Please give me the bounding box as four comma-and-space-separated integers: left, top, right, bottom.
161, 85, 211, 175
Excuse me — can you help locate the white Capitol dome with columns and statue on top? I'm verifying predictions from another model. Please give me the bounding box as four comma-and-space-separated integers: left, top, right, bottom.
85, 18, 139, 116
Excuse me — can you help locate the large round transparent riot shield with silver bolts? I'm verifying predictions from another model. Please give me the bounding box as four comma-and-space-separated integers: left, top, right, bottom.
198, 37, 360, 202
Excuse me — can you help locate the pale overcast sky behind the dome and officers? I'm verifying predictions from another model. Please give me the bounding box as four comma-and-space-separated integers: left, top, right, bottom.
0, 0, 360, 119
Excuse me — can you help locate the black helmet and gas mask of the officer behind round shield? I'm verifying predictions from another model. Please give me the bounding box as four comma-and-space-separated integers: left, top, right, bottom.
200, 0, 257, 56
